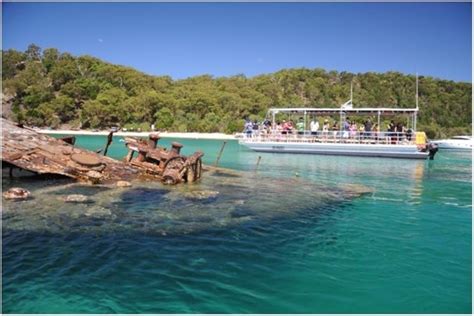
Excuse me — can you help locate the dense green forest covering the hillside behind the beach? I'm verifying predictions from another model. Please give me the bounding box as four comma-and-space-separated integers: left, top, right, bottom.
2, 44, 472, 137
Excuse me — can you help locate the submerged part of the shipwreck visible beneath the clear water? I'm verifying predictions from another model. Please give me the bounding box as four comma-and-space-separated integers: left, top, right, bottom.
3, 166, 372, 237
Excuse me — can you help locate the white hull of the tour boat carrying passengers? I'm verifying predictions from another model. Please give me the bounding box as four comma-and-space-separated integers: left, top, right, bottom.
239, 139, 429, 159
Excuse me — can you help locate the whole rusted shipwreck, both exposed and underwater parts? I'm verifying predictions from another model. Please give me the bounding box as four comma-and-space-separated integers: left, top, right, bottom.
1, 120, 372, 236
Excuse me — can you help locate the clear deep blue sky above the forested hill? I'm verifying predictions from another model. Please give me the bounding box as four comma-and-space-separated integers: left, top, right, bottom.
2, 3, 472, 82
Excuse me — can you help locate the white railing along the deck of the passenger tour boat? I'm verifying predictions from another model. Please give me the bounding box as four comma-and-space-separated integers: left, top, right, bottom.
243, 130, 416, 145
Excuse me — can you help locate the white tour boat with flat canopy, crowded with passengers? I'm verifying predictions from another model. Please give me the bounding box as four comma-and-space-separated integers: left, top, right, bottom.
239, 100, 437, 159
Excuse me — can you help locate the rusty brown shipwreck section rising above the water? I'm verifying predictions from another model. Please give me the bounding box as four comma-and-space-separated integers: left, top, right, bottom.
0, 118, 203, 184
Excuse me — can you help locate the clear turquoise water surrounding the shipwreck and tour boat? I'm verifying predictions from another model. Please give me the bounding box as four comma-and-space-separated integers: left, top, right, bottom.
2, 136, 472, 313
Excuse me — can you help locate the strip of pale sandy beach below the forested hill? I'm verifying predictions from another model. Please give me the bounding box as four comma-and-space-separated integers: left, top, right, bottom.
36, 129, 236, 140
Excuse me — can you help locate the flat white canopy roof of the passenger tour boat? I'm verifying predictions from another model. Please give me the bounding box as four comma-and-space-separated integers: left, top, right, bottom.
268, 107, 418, 115
